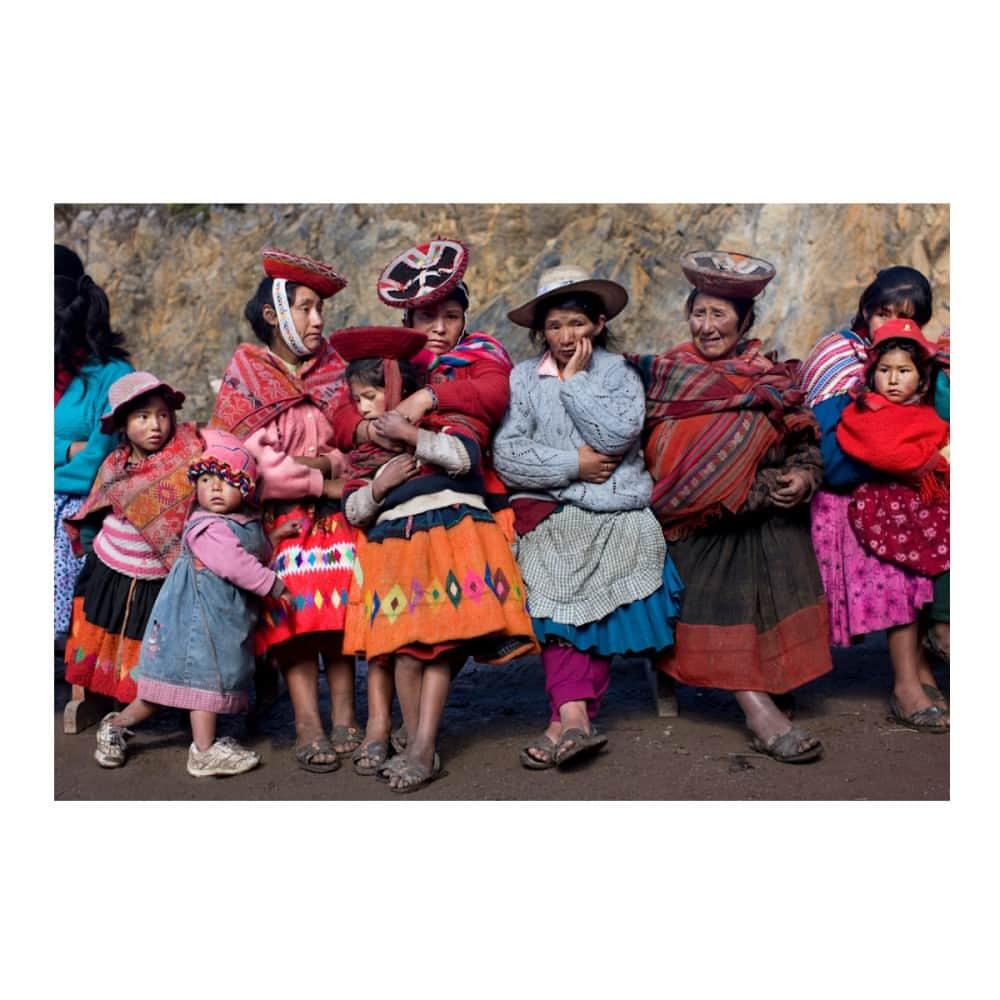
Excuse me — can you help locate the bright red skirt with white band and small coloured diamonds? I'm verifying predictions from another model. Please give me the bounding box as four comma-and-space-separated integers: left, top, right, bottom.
254, 500, 357, 656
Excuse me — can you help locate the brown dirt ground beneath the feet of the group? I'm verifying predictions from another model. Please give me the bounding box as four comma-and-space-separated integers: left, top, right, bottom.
53, 637, 951, 801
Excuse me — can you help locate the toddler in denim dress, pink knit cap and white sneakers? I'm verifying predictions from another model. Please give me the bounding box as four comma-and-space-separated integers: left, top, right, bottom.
94, 430, 297, 777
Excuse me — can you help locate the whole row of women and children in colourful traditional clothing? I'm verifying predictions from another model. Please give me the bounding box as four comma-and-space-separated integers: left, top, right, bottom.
55, 239, 950, 792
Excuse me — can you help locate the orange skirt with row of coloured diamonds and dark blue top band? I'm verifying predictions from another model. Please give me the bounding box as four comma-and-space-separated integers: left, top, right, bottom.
344, 505, 538, 663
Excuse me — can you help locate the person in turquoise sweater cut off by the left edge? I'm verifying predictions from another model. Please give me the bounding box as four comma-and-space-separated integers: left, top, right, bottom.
54, 243, 132, 652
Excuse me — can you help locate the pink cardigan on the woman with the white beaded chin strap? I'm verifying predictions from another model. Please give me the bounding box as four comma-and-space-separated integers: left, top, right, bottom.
243, 402, 347, 500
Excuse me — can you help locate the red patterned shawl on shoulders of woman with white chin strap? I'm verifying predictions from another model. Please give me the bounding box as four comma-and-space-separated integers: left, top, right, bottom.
208, 341, 348, 438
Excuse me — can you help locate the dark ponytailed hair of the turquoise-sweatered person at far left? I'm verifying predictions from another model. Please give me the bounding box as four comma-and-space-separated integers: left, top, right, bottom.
55, 243, 128, 368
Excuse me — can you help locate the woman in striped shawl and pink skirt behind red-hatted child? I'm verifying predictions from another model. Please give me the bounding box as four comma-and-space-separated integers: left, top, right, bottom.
800, 266, 949, 733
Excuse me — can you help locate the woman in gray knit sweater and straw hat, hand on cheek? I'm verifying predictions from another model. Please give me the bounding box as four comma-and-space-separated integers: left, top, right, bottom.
493, 265, 683, 769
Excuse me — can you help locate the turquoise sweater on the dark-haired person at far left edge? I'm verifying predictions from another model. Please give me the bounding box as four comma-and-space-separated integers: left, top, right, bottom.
55, 357, 133, 497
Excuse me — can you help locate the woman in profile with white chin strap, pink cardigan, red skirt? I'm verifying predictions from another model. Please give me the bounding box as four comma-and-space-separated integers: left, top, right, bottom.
210, 248, 361, 773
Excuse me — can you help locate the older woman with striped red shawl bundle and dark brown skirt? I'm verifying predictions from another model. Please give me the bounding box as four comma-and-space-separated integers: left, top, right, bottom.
633, 251, 832, 763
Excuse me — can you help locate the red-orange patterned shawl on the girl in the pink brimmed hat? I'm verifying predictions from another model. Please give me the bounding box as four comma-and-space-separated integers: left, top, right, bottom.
63, 423, 204, 569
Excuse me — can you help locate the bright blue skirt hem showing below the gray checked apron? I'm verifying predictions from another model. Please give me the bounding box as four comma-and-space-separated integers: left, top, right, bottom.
532, 553, 684, 656
